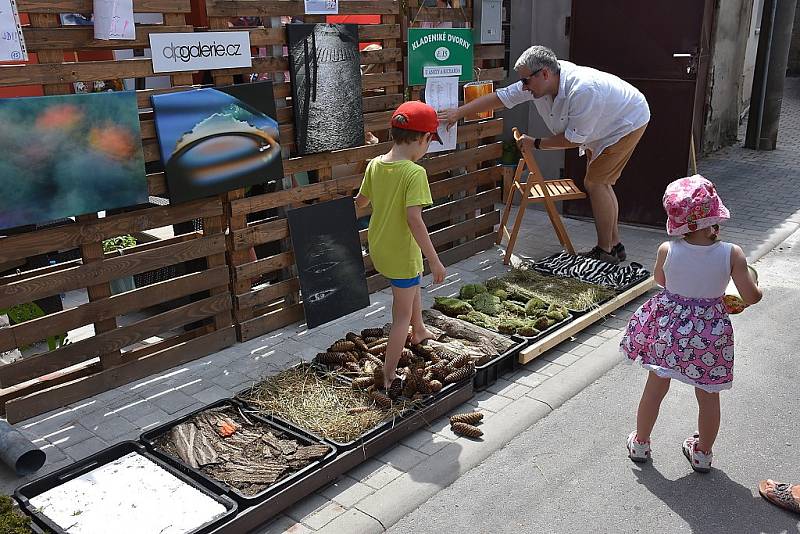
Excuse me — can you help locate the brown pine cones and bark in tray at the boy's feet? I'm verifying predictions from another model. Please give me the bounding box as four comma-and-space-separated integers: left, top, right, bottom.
314, 320, 490, 402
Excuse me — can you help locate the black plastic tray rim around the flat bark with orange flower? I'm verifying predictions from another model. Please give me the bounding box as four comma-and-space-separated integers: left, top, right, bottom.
140, 399, 337, 506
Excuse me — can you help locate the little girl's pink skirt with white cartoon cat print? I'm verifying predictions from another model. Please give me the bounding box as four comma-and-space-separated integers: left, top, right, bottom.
620, 290, 733, 392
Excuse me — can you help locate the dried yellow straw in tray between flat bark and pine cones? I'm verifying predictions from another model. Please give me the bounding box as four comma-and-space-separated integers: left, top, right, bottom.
240, 365, 410, 442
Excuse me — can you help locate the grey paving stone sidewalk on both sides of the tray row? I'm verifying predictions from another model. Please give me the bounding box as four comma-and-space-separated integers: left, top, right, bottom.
0, 79, 800, 534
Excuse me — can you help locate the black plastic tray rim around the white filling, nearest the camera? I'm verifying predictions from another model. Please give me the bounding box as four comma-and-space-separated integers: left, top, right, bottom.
14, 441, 238, 534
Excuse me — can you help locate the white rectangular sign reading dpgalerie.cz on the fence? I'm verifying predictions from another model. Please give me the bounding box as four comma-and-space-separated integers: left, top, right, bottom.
150, 32, 253, 72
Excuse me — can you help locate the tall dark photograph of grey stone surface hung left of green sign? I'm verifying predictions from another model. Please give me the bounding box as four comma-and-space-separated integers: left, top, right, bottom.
286, 24, 364, 154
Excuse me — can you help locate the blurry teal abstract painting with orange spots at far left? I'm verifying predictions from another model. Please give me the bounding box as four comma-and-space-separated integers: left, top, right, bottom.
0, 92, 147, 228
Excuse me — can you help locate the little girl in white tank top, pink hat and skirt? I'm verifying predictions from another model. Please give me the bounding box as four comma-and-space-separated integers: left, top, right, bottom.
620, 175, 761, 472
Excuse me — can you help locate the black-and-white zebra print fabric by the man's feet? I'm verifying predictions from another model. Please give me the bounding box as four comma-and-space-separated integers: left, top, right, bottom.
533, 252, 650, 291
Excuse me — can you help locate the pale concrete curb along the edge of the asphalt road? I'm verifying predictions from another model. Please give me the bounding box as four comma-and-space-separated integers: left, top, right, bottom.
318, 332, 623, 534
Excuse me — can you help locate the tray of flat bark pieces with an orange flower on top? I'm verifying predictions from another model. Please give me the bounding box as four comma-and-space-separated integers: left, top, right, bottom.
141, 399, 337, 506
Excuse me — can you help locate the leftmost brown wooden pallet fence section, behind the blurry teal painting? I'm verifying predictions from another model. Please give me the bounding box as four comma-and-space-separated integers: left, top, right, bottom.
0, 0, 235, 422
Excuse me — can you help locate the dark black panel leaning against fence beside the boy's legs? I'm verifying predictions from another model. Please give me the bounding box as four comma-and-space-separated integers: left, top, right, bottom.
287, 197, 369, 328
